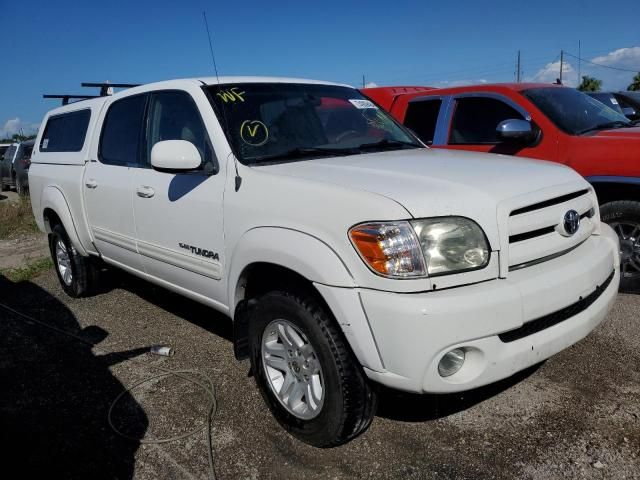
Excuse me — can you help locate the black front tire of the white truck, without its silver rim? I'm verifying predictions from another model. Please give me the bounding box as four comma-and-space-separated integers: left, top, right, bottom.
249, 291, 377, 448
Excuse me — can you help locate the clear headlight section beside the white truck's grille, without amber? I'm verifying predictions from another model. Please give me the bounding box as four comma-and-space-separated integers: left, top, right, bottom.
411, 217, 489, 276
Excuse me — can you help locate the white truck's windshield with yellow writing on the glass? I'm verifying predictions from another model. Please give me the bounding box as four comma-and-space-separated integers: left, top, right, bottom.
208, 83, 423, 164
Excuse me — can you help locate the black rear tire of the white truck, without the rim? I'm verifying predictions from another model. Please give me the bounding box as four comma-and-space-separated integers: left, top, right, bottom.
49, 224, 98, 298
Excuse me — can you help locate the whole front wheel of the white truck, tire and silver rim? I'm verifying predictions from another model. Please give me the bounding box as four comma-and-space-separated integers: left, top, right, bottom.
249, 291, 377, 447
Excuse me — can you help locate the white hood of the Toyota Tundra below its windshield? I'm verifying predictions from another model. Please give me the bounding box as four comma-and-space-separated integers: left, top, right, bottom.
257, 149, 587, 219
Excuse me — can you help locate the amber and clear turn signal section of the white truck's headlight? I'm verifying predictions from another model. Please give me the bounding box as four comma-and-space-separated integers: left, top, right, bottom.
349, 222, 427, 278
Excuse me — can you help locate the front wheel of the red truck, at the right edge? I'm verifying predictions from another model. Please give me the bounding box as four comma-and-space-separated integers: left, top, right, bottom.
600, 200, 640, 289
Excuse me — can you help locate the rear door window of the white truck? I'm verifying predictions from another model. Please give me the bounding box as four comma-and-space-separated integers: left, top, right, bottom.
99, 94, 147, 167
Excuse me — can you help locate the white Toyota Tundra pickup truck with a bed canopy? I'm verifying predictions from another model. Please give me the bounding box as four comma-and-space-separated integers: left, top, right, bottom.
29, 77, 620, 446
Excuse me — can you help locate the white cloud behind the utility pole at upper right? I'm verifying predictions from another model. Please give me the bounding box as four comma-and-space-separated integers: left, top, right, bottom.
527, 47, 640, 90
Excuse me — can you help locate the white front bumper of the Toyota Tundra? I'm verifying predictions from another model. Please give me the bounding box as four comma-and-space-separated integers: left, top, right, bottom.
320, 225, 620, 393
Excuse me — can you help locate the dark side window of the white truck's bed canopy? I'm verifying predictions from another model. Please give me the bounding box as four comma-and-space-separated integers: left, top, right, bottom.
40, 109, 91, 152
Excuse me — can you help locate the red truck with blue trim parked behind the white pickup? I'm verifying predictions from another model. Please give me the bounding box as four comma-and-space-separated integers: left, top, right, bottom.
362, 83, 640, 285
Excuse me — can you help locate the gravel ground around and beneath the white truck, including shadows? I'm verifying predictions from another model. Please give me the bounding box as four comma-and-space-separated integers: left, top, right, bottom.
0, 272, 640, 479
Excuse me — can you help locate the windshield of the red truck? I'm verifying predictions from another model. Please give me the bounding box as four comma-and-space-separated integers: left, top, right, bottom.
522, 87, 631, 135
